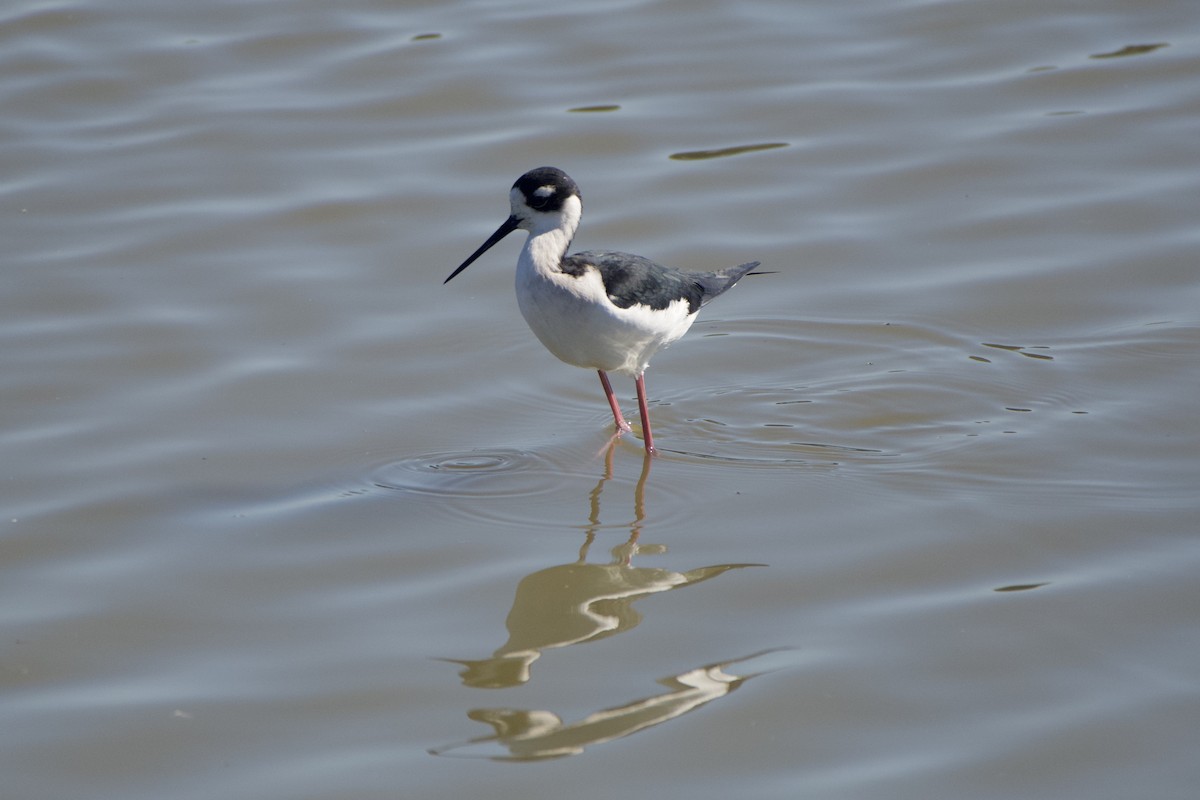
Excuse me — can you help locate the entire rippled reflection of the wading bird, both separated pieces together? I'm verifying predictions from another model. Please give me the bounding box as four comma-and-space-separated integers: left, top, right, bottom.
431, 448, 761, 760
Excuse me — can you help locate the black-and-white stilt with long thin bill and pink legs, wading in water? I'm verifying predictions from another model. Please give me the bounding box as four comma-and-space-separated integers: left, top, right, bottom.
445, 167, 758, 453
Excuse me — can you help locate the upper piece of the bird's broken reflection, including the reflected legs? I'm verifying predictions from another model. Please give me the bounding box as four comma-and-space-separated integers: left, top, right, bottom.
448, 443, 757, 688
